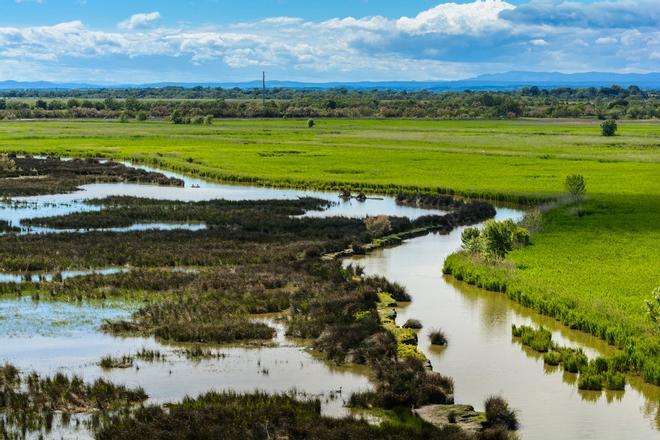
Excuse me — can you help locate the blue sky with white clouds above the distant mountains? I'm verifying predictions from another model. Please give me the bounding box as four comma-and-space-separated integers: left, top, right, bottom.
0, 0, 660, 83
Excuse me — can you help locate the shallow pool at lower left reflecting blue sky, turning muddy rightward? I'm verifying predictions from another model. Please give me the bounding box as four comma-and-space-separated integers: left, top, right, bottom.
0, 299, 371, 416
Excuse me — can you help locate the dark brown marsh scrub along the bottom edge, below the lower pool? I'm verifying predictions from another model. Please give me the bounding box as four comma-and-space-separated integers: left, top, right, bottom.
97, 393, 471, 440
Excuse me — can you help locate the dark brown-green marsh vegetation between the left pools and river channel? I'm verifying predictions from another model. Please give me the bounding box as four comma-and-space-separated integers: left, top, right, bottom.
0, 161, 508, 438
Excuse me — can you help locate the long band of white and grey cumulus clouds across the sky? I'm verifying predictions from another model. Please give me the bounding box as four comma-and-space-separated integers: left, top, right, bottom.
0, 0, 660, 79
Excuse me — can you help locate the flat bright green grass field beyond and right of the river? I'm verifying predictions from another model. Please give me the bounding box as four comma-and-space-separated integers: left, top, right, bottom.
0, 120, 660, 380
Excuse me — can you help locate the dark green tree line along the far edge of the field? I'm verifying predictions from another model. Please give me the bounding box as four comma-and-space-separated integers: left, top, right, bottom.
0, 86, 660, 122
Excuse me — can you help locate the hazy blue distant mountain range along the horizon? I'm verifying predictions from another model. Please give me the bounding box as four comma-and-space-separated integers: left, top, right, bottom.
0, 71, 660, 92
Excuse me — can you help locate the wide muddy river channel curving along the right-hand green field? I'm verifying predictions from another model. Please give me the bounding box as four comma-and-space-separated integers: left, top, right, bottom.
346, 209, 660, 440
